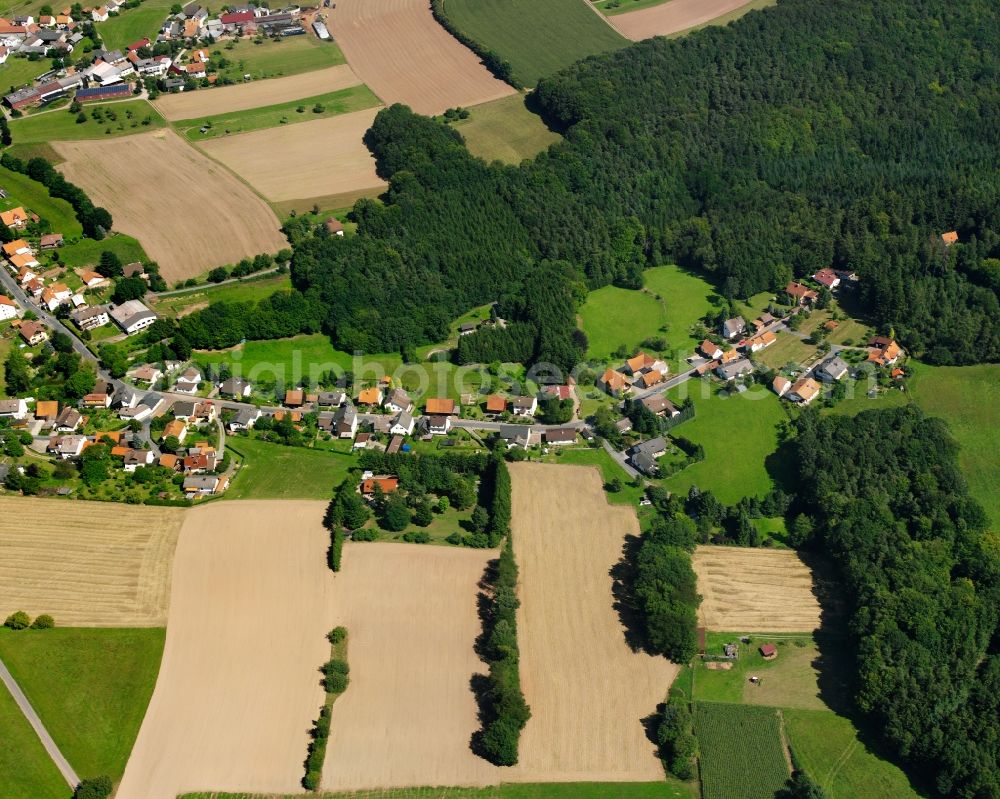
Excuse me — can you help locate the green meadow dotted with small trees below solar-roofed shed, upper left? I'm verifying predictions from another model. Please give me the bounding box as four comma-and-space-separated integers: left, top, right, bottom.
10, 100, 167, 144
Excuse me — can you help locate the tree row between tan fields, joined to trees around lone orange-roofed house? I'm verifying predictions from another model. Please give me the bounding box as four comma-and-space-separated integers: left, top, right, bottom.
324, 442, 531, 764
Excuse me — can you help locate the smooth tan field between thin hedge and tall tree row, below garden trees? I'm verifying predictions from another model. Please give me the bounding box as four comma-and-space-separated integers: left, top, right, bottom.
323, 543, 500, 791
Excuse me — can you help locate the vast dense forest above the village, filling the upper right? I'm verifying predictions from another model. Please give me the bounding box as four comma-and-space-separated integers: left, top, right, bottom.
150, 0, 1000, 368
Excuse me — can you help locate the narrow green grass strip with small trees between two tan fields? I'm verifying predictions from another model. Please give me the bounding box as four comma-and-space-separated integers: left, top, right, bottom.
173, 85, 379, 142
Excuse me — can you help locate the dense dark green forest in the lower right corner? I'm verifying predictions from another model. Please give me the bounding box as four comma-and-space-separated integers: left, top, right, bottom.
795, 406, 1000, 799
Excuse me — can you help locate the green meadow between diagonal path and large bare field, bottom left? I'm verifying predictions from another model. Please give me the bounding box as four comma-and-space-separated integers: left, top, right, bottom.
0, 619, 164, 780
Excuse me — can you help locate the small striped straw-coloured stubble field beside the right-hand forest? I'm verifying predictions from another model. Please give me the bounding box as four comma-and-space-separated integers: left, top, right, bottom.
694, 546, 820, 632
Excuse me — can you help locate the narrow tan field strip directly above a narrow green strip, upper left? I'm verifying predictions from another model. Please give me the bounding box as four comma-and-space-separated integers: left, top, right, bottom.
153, 64, 361, 122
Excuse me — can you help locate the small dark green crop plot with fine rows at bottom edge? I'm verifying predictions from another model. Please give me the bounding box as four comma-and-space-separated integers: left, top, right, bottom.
694, 702, 789, 799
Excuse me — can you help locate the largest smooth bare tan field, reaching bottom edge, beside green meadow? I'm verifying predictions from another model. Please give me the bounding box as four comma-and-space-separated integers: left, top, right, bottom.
116, 501, 333, 799
